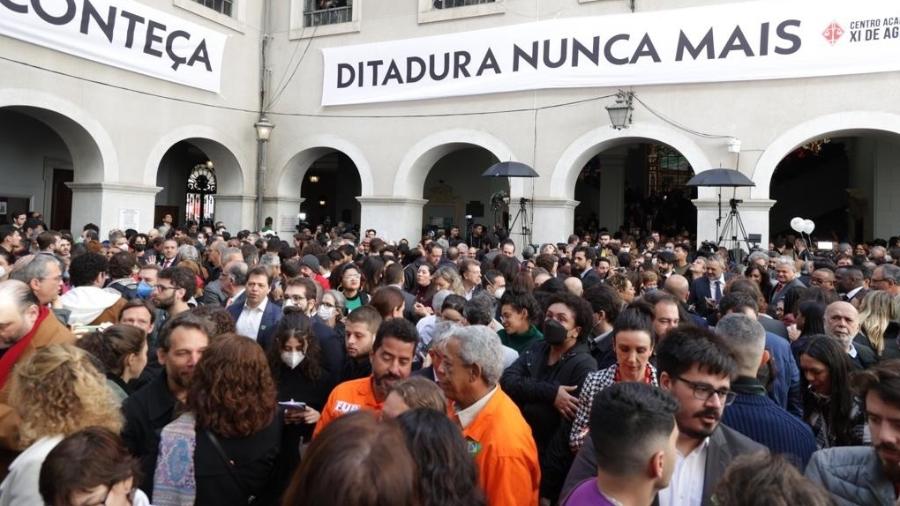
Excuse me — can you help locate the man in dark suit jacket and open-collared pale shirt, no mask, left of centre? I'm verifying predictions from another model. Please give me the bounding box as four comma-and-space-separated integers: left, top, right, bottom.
227, 266, 282, 350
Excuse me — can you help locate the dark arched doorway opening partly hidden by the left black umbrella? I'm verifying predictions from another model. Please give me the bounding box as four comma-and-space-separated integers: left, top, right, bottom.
422, 144, 506, 238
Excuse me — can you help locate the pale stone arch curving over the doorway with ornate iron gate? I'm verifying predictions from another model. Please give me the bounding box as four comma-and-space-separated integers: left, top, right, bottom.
143, 125, 253, 195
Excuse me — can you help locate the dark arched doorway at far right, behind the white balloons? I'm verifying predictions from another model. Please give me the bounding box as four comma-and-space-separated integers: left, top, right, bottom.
769, 130, 900, 242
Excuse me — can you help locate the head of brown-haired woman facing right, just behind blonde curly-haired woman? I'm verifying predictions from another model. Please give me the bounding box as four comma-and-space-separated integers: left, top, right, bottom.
76, 325, 147, 403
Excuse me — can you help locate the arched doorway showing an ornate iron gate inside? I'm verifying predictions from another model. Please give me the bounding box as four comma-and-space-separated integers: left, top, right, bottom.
153, 138, 243, 229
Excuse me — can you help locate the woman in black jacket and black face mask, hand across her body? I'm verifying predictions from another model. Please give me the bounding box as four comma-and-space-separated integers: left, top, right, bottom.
500, 292, 597, 501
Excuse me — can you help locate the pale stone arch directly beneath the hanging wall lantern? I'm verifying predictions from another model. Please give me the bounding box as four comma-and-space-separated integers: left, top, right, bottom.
550, 124, 713, 200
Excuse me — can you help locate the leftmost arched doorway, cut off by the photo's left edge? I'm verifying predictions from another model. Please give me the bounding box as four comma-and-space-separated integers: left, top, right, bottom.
0, 106, 104, 230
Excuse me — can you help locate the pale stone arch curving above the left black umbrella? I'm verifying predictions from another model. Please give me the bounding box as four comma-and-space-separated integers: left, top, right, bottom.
394, 128, 525, 199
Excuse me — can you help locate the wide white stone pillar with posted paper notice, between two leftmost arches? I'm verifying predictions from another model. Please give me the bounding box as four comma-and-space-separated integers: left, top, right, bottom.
66, 182, 162, 238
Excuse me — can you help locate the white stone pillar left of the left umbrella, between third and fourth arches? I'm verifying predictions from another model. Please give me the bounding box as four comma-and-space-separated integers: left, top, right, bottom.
356, 196, 428, 245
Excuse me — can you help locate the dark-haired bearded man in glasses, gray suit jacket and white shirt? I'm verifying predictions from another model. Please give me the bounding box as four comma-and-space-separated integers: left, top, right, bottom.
560, 327, 767, 506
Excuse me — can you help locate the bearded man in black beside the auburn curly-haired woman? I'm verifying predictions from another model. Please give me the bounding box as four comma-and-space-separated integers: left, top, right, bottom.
122, 312, 211, 496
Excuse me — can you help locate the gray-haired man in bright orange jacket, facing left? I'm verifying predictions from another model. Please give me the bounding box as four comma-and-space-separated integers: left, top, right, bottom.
439, 325, 541, 506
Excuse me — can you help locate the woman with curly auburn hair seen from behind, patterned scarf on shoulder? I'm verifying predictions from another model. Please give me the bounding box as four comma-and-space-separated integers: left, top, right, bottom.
153, 334, 282, 506
